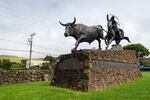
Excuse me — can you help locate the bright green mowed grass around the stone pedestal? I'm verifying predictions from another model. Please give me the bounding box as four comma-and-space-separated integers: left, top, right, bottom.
0, 72, 150, 100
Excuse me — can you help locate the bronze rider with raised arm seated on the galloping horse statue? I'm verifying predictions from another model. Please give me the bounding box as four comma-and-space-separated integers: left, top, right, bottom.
107, 15, 123, 38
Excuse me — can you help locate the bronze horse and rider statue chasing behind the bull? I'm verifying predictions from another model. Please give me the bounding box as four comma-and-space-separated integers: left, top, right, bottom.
105, 14, 130, 50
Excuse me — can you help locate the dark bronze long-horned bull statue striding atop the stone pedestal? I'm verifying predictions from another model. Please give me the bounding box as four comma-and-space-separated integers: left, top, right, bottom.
59, 17, 104, 51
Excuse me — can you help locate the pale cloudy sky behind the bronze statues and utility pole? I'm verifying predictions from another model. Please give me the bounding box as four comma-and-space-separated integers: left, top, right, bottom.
0, 0, 150, 58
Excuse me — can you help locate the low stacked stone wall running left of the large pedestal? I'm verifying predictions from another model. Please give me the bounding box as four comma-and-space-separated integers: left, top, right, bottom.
0, 70, 53, 85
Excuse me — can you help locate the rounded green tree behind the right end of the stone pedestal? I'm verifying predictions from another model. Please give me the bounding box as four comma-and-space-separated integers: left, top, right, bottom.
123, 43, 150, 57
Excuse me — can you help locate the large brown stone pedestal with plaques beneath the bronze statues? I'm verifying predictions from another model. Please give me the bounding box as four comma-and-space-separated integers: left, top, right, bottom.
52, 50, 141, 91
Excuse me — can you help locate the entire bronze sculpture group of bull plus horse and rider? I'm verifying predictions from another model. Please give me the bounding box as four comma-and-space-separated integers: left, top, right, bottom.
59, 14, 130, 51
